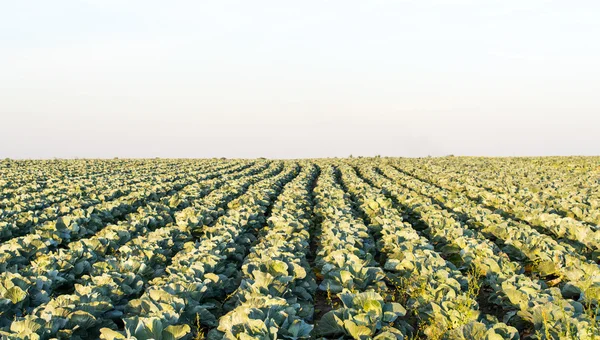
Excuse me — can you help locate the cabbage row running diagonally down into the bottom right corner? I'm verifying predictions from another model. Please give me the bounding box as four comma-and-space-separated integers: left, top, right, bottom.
358, 166, 597, 339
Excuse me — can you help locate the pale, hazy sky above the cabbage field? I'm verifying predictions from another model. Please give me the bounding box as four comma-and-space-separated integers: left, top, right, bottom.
0, 0, 600, 158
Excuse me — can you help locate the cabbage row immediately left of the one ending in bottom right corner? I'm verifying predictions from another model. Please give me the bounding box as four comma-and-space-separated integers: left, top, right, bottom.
340, 165, 518, 339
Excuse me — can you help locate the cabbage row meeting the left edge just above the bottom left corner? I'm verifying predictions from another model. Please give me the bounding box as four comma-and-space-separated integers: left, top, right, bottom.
0, 161, 270, 326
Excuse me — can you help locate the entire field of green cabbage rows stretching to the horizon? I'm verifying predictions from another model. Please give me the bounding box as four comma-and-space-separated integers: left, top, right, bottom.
0, 157, 600, 340
